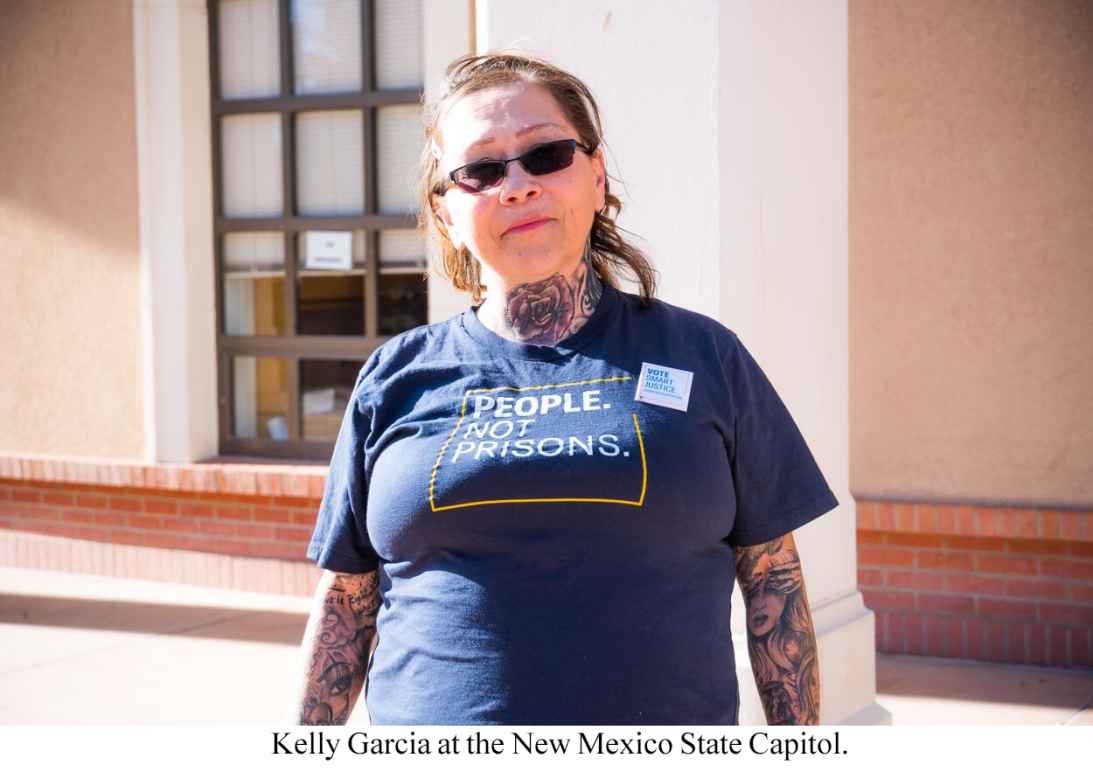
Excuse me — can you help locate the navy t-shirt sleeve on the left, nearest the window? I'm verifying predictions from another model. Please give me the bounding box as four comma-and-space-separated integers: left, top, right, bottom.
307, 370, 379, 574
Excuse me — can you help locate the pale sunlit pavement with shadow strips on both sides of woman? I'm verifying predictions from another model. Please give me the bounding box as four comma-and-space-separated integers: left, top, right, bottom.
0, 568, 1093, 726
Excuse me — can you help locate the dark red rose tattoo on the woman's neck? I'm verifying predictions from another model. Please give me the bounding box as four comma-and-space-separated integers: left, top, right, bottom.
484, 250, 603, 346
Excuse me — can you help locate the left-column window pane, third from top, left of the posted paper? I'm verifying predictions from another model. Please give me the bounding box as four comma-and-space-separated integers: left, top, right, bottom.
223, 232, 285, 335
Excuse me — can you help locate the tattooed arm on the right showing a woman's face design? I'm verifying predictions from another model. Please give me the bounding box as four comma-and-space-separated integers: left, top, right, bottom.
733, 534, 820, 726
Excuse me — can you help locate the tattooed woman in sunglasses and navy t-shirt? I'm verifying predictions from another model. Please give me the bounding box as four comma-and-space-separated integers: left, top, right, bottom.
290, 55, 837, 725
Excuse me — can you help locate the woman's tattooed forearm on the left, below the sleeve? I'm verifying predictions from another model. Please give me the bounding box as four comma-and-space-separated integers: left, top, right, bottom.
295, 571, 379, 724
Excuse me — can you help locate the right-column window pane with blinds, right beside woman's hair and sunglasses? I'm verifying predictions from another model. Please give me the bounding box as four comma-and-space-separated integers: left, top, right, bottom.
376, 105, 424, 214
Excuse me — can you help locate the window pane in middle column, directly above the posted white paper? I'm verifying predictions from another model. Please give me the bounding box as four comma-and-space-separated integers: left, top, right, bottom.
296, 110, 364, 217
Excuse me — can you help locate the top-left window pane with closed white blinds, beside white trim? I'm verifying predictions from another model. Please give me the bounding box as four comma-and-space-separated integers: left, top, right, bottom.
218, 0, 281, 100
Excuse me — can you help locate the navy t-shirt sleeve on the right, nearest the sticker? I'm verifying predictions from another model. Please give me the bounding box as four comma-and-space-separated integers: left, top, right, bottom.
722, 334, 838, 547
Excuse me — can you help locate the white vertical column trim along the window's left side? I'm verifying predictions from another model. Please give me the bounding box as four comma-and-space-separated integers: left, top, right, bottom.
133, 0, 218, 463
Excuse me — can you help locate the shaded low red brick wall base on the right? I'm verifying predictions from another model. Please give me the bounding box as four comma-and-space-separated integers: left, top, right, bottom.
858, 501, 1093, 667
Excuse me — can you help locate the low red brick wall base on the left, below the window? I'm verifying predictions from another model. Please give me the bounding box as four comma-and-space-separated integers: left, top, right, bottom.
0, 456, 327, 594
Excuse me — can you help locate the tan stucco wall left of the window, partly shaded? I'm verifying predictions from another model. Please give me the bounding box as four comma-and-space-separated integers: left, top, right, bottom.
0, 0, 143, 457
